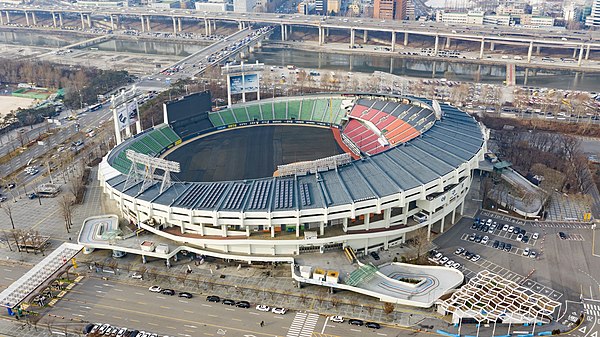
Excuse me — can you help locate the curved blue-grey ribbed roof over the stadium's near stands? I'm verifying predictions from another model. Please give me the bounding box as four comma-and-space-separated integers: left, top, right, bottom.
108, 100, 484, 212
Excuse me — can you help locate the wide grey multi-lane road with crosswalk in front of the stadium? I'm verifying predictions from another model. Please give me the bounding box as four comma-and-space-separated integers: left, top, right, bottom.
42, 277, 402, 337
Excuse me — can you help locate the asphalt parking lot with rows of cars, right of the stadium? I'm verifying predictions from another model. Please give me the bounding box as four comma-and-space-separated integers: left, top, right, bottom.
434, 211, 600, 301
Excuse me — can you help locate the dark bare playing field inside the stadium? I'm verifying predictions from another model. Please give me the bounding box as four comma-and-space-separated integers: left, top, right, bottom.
167, 125, 343, 181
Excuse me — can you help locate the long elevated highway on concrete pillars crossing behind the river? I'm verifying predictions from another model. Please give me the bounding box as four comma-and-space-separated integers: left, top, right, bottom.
0, 5, 600, 66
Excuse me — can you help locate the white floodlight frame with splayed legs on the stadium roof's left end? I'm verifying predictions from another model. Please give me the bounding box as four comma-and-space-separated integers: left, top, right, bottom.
124, 150, 181, 193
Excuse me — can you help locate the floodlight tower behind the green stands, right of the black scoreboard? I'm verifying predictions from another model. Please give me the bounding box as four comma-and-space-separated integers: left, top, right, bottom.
221, 61, 265, 107
